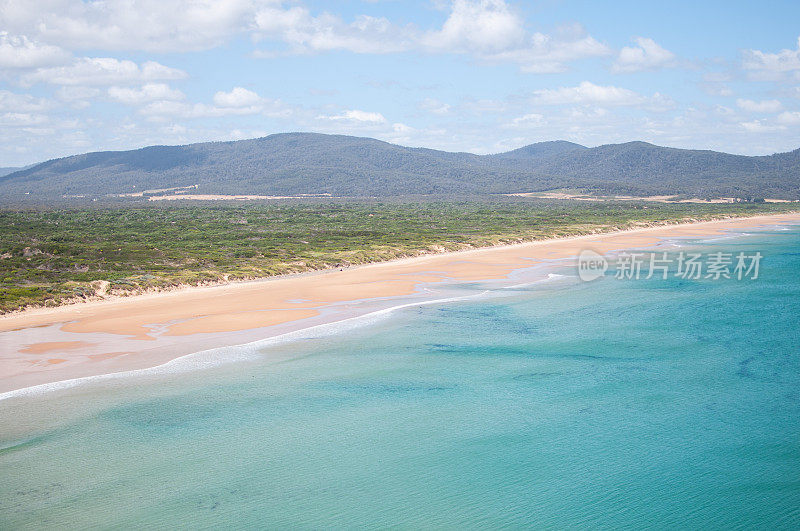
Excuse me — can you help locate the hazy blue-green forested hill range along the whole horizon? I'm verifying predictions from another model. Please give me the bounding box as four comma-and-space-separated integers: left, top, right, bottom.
0, 133, 800, 199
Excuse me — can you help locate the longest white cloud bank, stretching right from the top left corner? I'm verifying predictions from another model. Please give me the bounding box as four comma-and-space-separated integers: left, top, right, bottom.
0, 0, 611, 73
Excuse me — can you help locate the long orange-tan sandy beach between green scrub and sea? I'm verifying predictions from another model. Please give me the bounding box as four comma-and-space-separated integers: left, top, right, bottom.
0, 214, 800, 392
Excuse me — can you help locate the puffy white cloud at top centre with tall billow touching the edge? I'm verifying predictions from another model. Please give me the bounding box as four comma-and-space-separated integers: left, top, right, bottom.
255, 0, 611, 73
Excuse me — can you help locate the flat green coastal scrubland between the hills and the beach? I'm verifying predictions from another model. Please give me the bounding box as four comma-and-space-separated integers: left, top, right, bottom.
0, 200, 791, 312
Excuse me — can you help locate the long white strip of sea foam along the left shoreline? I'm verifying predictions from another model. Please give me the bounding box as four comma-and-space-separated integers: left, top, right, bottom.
0, 290, 490, 401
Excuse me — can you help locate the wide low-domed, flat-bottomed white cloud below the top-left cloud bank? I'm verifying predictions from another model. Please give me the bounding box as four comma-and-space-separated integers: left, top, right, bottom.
21, 57, 186, 86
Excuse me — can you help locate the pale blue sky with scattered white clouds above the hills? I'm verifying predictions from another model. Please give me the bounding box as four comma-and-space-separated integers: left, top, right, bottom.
0, 0, 800, 166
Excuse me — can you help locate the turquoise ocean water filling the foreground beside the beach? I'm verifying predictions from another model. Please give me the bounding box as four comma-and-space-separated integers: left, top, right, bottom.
0, 227, 800, 529
